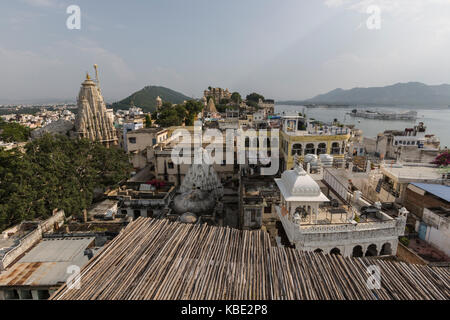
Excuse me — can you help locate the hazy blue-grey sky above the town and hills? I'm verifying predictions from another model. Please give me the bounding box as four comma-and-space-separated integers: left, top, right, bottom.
0, 0, 450, 103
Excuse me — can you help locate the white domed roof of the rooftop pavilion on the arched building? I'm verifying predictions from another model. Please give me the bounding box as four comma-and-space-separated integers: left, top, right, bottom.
281, 167, 321, 197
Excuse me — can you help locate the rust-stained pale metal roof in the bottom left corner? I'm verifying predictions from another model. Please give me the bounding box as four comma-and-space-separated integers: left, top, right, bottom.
0, 238, 95, 286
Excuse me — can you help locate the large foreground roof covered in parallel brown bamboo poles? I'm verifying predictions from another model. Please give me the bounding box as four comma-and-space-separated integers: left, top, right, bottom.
51, 218, 450, 300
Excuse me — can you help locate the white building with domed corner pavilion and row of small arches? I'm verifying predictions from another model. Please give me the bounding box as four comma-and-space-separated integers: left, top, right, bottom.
275, 165, 407, 257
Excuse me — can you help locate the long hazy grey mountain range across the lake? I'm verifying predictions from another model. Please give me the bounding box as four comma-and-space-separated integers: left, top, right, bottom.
277, 82, 450, 107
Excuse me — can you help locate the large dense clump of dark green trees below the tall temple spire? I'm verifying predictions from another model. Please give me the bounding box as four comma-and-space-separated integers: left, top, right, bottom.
0, 134, 131, 230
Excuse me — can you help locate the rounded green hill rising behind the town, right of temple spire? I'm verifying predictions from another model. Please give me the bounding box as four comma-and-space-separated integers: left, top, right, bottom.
112, 86, 192, 112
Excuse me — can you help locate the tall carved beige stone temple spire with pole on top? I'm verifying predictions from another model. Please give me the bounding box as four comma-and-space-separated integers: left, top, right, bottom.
75, 65, 118, 147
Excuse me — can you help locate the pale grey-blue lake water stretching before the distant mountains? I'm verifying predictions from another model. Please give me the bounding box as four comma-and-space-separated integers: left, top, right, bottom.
275, 105, 450, 148
